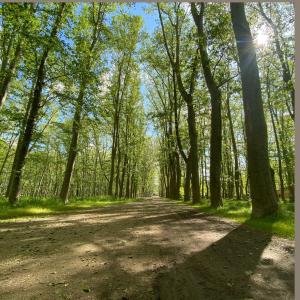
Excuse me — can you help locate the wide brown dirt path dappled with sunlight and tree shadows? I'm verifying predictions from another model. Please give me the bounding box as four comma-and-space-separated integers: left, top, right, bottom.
0, 198, 294, 300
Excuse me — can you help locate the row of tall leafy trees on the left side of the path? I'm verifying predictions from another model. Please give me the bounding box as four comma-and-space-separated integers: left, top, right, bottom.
0, 3, 154, 204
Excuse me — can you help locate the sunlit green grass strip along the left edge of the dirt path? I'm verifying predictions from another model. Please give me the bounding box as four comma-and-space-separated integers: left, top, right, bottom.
0, 196, 136, 222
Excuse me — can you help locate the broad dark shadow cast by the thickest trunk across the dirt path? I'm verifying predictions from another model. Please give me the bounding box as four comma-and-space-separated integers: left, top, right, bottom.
153, 223, 294, 300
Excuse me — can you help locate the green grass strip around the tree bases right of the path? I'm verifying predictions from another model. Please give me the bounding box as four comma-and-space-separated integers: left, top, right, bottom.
177, 200, 295, 239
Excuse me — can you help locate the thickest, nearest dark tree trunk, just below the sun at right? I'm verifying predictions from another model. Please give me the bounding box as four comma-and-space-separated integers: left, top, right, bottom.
230, 3, 278, 217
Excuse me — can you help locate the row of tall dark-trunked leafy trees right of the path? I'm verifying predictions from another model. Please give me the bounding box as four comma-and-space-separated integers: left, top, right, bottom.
144, 3, 294, 216
